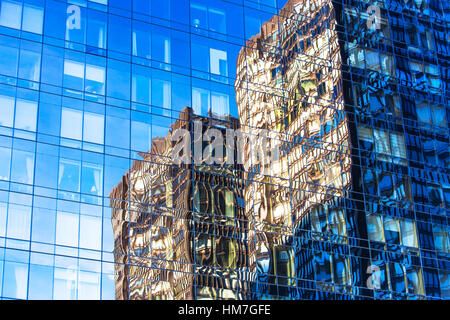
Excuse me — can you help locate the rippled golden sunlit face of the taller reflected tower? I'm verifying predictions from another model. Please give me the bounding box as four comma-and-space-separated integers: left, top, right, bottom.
235, 0, 352, 298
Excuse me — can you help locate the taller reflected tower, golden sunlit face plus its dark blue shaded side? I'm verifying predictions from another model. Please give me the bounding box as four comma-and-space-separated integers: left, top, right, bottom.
235, 0, 449, 299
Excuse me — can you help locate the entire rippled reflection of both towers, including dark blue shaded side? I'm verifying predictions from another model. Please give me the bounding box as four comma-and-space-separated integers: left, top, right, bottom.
111, 0, 449, 299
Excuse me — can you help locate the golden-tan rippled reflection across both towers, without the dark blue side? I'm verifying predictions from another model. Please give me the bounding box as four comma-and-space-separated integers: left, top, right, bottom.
110, 0, 351, 299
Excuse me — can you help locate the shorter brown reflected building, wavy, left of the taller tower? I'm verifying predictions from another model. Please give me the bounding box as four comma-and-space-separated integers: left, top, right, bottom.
110, 108, 249, 300
